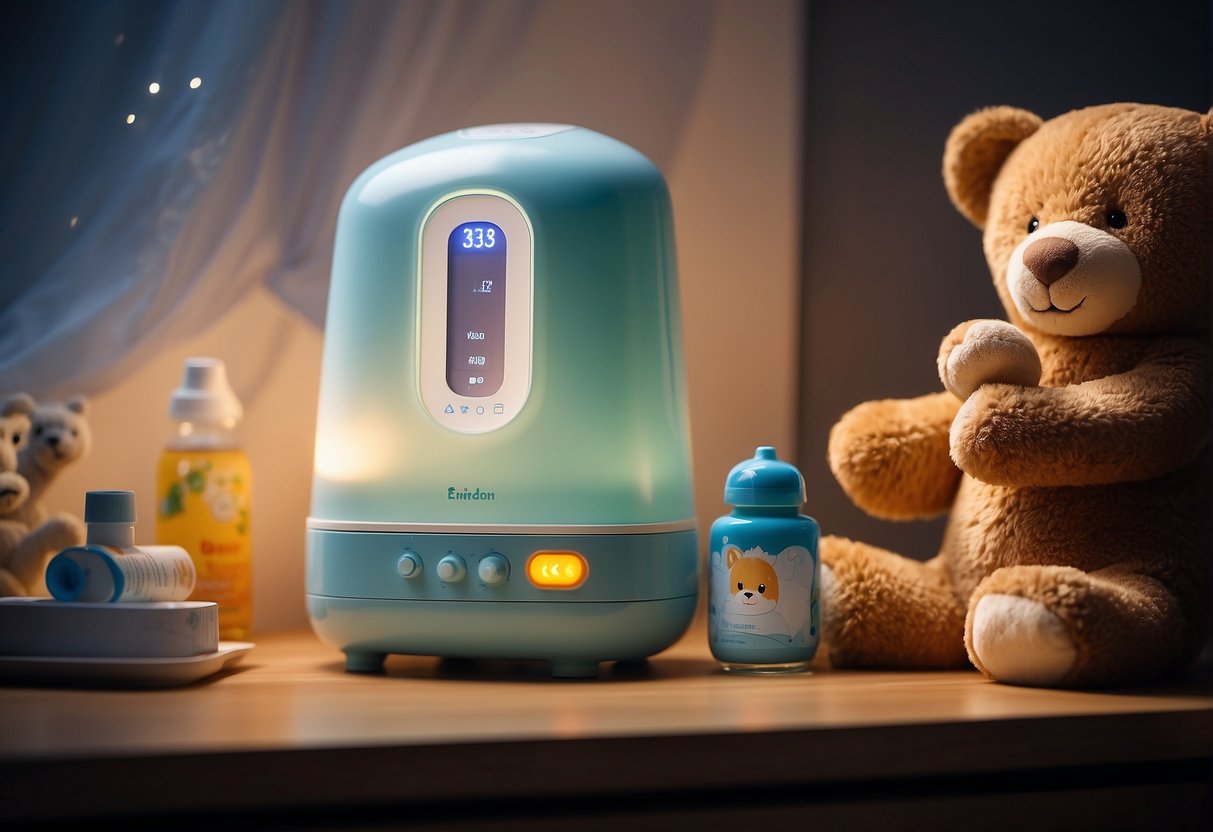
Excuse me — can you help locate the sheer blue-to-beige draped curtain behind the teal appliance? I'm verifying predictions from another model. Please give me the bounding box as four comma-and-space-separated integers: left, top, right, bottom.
0, 0, 714, 398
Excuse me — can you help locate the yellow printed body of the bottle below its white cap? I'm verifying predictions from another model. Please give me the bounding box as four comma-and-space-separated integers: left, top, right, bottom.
156, 450, 252, 639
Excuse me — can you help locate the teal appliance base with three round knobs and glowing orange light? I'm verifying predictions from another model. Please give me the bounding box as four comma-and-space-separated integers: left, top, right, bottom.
307, 520, 700, 677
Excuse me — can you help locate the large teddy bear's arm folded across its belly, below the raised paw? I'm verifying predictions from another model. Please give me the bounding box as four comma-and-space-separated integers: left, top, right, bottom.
951, 348, 1209, 486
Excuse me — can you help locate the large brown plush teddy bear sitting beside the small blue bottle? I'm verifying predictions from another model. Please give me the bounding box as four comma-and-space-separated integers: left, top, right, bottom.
821, 103, 1213, 686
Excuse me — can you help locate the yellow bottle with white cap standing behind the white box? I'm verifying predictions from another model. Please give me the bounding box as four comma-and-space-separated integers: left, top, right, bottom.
155, 358, 252, 642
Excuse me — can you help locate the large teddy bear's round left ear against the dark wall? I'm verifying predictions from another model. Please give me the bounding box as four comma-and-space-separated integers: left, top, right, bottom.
944, 107, 1043, 228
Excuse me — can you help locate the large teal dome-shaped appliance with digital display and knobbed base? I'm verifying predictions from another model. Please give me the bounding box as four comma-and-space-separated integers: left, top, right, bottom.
306, 124, 700, 677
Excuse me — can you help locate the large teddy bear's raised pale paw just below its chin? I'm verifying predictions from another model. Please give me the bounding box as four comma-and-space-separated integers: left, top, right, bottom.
938, 320, 1041, 400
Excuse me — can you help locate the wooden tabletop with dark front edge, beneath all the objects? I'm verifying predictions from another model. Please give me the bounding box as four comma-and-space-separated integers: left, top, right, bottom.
0, 621, 1213, 820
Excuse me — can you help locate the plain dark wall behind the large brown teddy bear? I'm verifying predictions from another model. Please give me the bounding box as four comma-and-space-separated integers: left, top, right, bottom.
798, 0, 1213, 558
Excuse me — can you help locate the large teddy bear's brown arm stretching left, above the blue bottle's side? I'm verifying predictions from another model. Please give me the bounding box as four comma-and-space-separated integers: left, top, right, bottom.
828, 393, 961, 519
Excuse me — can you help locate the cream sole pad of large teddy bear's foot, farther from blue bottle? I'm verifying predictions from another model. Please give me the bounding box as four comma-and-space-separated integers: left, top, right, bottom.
972, 593, 1077, 686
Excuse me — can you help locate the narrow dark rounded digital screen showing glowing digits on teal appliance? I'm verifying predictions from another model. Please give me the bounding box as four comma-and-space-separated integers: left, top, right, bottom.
446, 222, 506, 398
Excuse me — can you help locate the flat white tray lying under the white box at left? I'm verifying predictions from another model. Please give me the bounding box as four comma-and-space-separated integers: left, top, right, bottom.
0, 642, 255, 688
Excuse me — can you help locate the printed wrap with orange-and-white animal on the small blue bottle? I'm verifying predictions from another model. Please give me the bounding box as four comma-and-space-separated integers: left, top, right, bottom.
708, 536, 820, 661
